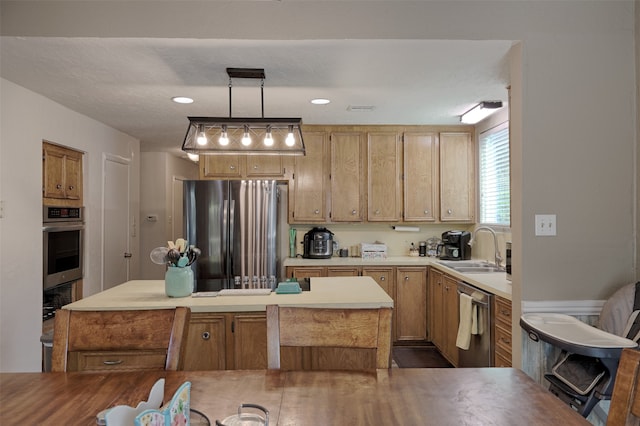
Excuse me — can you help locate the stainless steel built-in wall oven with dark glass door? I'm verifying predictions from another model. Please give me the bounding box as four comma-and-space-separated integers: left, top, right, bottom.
42, 206, 84, 289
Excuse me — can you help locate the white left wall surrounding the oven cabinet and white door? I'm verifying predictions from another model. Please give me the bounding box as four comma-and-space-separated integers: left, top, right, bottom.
0, 79, 139, 371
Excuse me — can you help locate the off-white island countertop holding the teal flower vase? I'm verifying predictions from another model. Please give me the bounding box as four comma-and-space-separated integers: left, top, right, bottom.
63, 277, 393, 312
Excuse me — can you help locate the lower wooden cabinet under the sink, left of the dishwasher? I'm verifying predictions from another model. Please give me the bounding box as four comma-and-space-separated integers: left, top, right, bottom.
429, 268, 460, 366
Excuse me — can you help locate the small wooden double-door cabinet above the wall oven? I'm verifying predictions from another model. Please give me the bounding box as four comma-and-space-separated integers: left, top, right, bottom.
42, 142, 83, 207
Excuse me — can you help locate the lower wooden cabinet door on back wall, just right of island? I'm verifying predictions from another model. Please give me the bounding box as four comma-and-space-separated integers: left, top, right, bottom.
395, 267, 427, 341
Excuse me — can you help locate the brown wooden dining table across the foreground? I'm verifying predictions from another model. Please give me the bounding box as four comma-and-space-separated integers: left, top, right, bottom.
0, 368, 589, 426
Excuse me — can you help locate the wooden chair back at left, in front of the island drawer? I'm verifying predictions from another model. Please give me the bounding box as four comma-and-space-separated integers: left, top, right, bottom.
51, 307, 191, 372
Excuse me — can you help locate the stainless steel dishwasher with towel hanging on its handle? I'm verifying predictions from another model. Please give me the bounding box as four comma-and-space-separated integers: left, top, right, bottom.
458, 281, 493, 367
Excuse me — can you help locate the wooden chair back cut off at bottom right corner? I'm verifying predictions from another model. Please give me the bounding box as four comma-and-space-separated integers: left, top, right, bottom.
607, 349, 640, 426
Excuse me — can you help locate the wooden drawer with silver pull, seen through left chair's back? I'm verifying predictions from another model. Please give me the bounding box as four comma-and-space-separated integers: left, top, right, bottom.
69, 349, 167, 371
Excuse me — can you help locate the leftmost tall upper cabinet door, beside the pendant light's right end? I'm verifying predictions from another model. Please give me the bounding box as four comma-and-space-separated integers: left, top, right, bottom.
289, 132, 329, 223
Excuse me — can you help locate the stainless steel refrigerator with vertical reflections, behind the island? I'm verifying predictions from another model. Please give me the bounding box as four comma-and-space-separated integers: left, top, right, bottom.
184, 180, 278, 291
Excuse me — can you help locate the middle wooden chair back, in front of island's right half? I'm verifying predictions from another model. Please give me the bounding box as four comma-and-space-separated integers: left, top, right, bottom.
267, 305, 391, 369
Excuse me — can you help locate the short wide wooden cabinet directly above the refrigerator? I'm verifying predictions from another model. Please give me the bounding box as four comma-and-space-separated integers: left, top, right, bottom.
200, 154, 287, 179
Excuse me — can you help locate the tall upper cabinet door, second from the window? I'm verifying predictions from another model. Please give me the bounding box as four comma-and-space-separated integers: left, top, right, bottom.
403, 133, 439, 222
